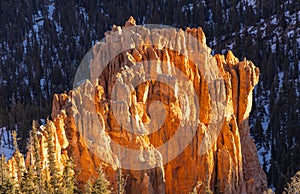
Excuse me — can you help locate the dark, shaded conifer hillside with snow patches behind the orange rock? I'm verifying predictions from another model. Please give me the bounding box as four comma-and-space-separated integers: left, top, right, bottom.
0, 0, 300, 193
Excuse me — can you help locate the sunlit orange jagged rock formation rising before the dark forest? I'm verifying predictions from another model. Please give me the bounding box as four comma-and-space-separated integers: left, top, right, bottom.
9, 18, 267, 193
